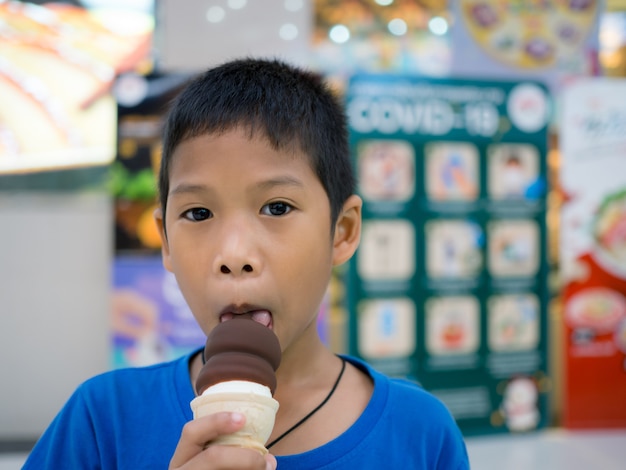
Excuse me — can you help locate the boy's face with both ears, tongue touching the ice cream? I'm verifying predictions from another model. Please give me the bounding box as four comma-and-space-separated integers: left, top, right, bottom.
156, 130, 361, 356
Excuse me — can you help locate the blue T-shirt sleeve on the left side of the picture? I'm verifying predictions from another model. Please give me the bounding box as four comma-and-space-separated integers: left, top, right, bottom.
22, 387, 101, 470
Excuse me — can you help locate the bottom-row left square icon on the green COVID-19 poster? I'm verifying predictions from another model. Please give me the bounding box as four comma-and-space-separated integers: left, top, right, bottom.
358, 298, 416, 358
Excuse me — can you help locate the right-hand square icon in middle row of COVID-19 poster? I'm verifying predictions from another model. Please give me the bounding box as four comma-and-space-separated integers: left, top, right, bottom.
487, 220, 539, 277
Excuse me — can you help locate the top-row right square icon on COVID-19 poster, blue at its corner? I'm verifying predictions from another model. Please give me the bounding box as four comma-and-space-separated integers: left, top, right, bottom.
487, 144, 544, 200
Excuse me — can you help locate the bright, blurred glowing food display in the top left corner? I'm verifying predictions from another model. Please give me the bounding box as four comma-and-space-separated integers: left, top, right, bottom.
0, 0, 152, 173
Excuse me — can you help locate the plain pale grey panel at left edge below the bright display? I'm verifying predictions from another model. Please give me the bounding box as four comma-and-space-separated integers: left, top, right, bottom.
0, 192, 113, 441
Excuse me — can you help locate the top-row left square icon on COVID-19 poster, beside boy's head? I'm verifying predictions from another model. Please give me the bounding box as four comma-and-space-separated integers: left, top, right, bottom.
357, 140, 415, 202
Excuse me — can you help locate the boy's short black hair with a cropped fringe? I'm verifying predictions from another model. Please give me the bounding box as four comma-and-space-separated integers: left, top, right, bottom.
159, 58, 355, 230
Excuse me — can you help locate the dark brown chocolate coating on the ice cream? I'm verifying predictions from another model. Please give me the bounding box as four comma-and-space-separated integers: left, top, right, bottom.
196, 315, 281, 395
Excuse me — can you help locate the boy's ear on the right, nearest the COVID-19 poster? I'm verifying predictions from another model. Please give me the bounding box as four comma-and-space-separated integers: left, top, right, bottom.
333, 194, 363, 266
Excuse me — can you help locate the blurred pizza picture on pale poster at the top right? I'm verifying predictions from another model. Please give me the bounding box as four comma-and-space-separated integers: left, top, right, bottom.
449, 0, 604, 94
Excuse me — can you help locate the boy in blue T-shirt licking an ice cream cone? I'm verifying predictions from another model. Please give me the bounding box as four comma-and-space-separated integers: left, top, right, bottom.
25, 59, 469, 470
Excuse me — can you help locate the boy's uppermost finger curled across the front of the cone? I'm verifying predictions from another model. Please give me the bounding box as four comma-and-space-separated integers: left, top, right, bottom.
170, 412, 246, 468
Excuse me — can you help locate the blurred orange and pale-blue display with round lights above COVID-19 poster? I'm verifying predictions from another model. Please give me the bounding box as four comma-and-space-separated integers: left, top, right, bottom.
311, 0, 452, 83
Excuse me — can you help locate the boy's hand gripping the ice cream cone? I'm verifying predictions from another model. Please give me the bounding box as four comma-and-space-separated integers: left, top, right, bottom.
169, 413, 276, 470
